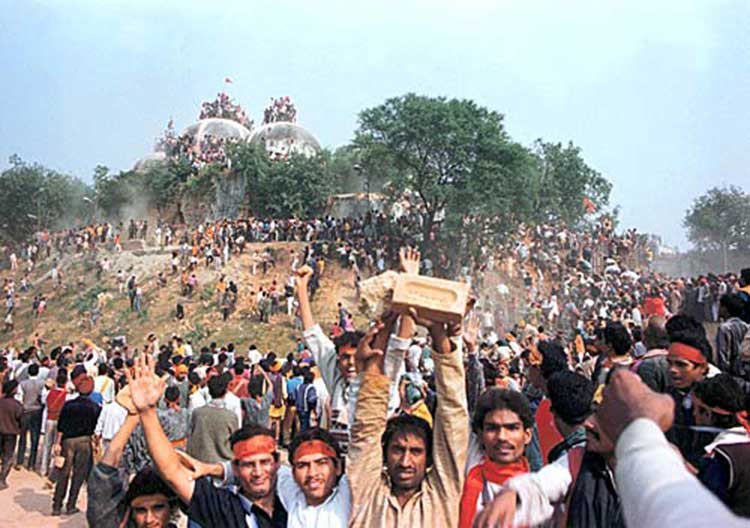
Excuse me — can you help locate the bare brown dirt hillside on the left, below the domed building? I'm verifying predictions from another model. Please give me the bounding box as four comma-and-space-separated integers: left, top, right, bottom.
0, 243, 362, 354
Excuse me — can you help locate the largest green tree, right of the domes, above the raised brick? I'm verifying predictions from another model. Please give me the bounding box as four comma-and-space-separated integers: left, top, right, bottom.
354, 94, 534, 260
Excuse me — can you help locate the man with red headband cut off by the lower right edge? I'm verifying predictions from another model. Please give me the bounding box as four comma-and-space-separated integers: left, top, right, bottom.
693, 374, 750, 517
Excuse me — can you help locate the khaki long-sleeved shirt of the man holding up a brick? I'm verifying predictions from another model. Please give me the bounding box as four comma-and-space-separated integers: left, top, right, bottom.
347, 350, 469, 528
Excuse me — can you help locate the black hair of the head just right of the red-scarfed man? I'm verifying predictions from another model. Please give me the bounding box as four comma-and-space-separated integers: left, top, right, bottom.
547, 370, 594, 426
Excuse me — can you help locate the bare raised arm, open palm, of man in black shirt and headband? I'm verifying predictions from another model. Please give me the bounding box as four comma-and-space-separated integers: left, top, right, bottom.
125, 354, 195, 504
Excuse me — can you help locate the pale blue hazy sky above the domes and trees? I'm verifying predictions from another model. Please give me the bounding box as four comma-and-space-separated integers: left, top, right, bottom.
0, 0, 750, 246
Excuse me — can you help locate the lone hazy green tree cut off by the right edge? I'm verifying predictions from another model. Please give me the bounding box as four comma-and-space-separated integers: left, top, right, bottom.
682, 186, 750, 269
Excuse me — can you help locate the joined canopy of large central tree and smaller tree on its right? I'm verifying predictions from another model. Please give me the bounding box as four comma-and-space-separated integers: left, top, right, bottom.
354, 94, 611, 264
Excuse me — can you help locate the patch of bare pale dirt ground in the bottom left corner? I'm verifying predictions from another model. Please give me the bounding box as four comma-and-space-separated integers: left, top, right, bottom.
0, 469, 86, 528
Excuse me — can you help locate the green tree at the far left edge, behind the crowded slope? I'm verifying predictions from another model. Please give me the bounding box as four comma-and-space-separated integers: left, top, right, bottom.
0, 155, 91, 243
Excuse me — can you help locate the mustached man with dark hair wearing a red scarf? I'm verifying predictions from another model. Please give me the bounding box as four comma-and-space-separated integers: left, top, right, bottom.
458, 388, 534, 528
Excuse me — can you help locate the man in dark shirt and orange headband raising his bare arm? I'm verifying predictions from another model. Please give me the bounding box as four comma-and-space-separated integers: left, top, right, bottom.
127, 355, 287, 528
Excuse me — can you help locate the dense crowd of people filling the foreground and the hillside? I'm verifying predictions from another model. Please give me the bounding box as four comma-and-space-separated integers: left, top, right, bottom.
0, 208, 750, 528
